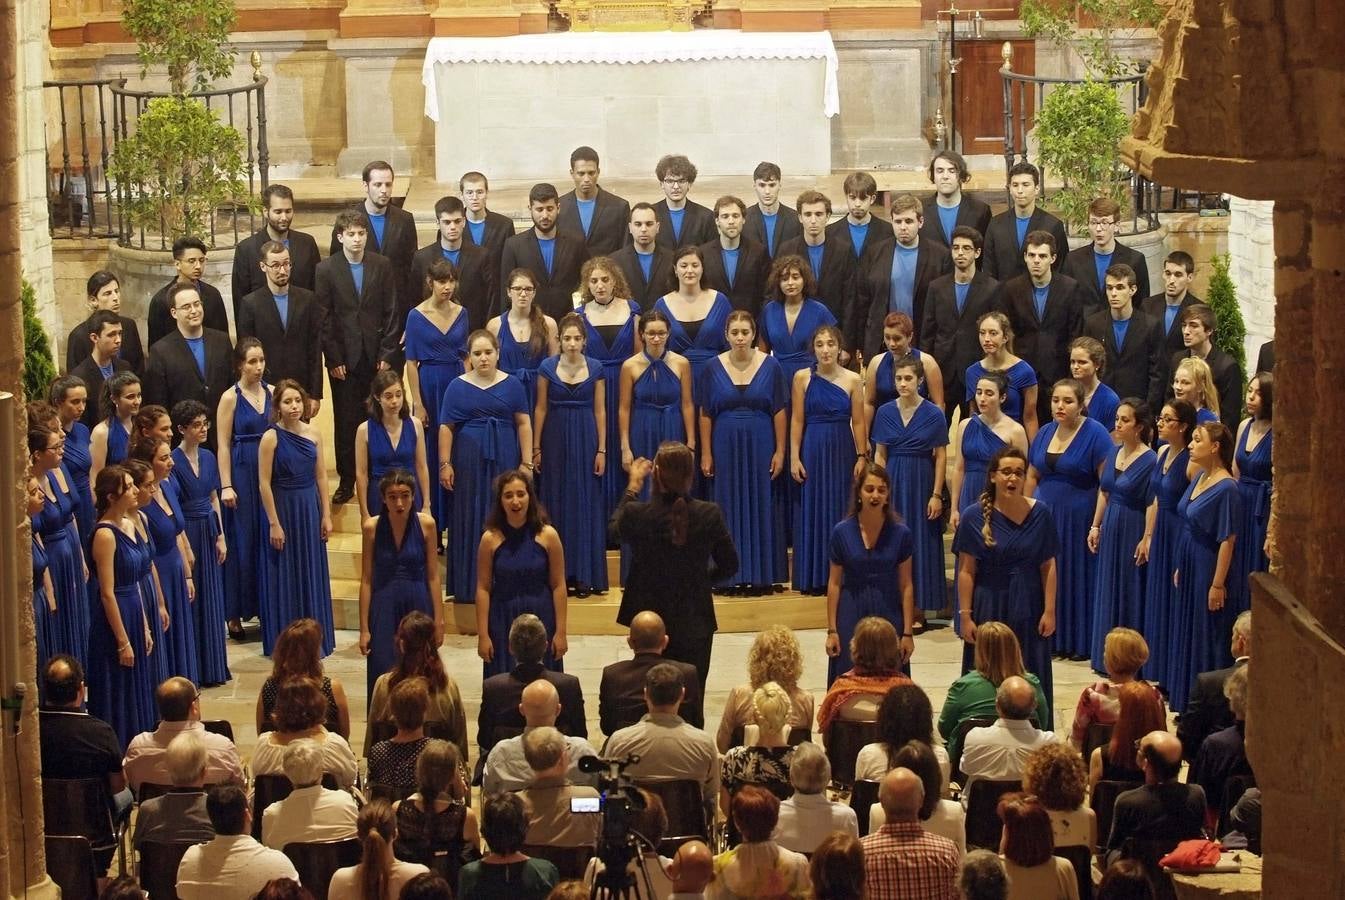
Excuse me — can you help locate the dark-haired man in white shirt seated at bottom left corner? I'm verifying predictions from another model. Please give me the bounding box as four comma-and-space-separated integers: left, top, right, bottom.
178, 782, 299, 900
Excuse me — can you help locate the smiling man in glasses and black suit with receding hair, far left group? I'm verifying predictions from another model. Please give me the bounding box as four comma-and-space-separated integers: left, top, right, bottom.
144, 284, 234, 451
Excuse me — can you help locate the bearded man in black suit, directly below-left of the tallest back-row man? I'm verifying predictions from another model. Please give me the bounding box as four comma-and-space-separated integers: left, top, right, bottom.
499, 182, 589, 322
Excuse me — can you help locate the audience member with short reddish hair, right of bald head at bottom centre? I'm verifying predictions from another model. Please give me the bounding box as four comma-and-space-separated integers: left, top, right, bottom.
705, 784, 808, 900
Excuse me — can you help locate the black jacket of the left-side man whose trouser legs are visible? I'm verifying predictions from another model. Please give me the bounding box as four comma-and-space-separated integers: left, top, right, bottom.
315, 252, 402, 369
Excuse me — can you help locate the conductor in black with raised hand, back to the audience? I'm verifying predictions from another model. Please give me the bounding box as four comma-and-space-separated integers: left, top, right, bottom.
608, 441, 738, 697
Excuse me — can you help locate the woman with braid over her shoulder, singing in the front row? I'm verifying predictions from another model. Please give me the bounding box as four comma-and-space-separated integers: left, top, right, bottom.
952, 445, 1059, 729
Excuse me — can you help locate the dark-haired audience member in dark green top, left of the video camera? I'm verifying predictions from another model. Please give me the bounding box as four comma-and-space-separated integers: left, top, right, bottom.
456, 792, 561, 900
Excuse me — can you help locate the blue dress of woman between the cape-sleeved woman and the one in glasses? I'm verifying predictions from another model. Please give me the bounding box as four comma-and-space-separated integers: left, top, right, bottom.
538, 357, 607, 591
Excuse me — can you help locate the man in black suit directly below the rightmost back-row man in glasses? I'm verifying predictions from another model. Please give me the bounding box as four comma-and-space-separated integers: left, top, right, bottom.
1084, 262, 1165, 406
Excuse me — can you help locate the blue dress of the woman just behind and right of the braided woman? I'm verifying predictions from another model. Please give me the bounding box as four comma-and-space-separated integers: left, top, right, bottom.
1028, 418, 1115, 656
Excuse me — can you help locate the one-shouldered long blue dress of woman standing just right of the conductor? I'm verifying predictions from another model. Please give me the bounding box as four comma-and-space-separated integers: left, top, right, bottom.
780, 371, 855, 591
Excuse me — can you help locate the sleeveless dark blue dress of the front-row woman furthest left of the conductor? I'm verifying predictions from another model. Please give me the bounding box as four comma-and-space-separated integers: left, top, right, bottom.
367, 513, 437, 697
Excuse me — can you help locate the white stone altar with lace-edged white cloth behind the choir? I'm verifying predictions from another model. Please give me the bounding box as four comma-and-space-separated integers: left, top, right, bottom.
421, 30, 841, 181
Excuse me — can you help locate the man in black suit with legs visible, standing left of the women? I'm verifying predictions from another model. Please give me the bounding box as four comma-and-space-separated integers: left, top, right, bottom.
316, 210, 402, 504
